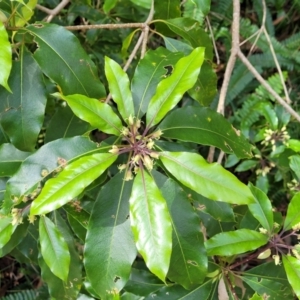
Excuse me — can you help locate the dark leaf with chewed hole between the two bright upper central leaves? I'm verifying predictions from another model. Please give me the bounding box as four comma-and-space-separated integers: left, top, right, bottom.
131, 47, 182, 118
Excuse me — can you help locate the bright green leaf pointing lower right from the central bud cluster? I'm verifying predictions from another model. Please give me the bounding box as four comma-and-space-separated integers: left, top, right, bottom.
160, 152, 254, 204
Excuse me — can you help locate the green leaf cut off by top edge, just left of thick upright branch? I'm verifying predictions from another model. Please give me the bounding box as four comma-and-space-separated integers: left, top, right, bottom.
183, 0, 211, 23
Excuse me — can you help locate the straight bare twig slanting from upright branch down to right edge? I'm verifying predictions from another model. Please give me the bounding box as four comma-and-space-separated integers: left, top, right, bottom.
238, 50, 300, 122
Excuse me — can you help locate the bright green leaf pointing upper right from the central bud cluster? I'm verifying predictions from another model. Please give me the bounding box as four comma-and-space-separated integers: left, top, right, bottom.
146, 48, 204, 126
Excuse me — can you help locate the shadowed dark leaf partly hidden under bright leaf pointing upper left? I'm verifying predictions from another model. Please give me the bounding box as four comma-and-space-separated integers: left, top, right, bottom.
44, 105, 93, 143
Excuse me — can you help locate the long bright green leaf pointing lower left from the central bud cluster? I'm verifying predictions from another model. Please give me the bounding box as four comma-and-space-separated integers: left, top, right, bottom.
30, 153, 117, 215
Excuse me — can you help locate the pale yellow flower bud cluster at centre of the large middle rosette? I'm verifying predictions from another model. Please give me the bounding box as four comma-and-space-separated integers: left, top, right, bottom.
109, 116, 162, 180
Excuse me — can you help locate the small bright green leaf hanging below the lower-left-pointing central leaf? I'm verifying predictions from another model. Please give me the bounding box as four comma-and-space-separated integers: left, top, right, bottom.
39, 216, 70, 281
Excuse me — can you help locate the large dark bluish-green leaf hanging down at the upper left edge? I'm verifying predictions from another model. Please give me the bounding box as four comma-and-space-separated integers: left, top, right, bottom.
0, 47, 47, 151
